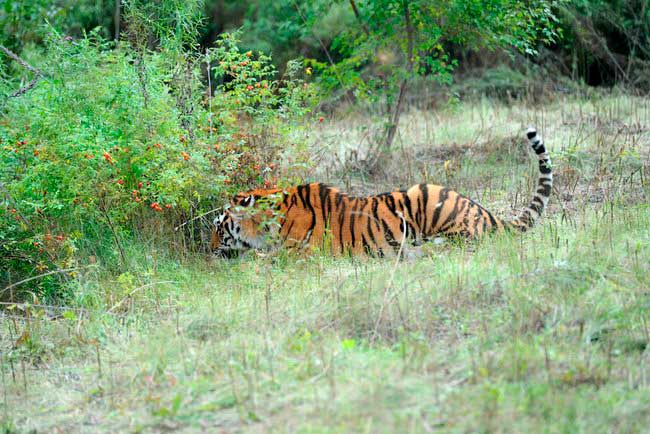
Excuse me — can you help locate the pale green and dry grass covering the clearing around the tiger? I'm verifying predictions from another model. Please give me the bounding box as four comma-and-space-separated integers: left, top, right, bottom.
0, 90, 650, 433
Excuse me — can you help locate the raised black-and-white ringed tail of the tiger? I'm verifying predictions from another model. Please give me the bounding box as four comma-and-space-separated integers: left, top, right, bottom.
508, 127, 553, 232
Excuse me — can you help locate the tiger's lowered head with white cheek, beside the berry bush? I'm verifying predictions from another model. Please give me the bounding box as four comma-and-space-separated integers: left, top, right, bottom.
210, 189, 281, 257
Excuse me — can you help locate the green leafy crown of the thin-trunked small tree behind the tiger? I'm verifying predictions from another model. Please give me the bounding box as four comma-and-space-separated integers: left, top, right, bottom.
306, 0, 557, 94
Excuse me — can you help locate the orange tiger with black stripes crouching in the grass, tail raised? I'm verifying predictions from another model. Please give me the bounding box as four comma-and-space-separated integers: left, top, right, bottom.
210, 127, 553, 257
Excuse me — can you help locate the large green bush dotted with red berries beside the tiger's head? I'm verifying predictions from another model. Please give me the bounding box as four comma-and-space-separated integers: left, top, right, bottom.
0, 6, 310, 297
